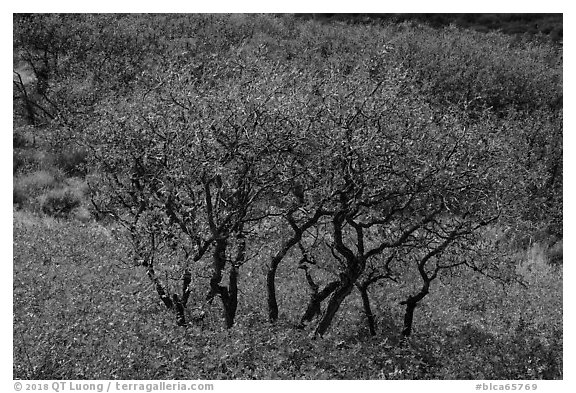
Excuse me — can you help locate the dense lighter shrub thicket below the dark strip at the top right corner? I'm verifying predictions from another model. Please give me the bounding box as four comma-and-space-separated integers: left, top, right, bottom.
394, 28, 562, 114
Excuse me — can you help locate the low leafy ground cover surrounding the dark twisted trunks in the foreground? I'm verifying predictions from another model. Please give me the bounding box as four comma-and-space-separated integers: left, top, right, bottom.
13, 211, 562, 379
